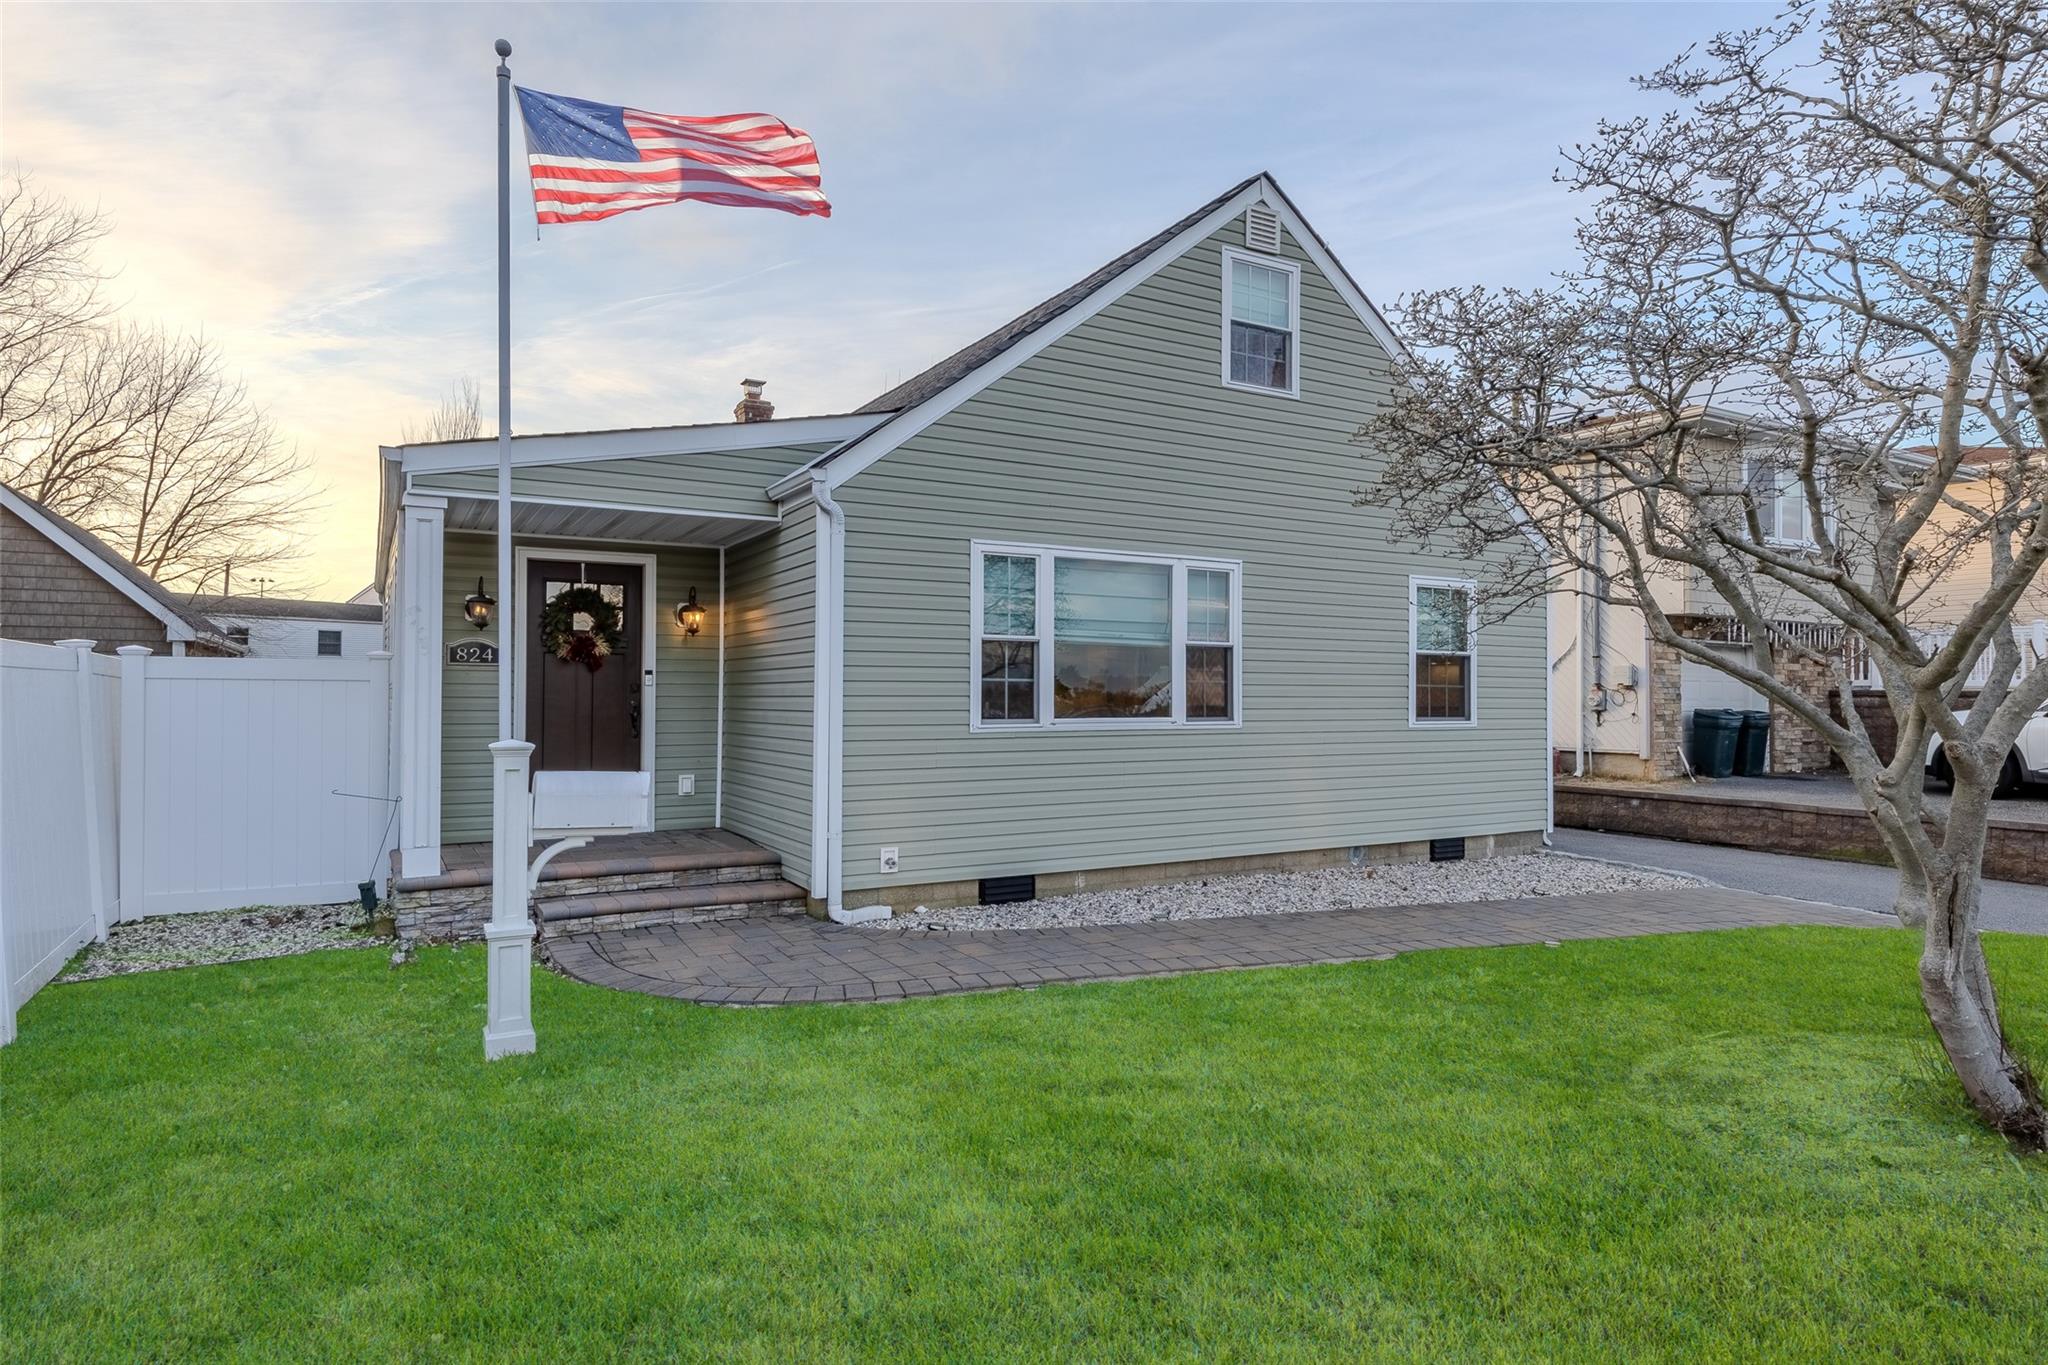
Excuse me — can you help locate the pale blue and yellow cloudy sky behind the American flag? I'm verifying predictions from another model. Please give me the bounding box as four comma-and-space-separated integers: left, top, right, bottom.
0, 4, 1769, 598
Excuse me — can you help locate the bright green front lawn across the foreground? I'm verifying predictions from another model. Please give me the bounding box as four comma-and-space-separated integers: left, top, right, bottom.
0, 929, 2048, 1361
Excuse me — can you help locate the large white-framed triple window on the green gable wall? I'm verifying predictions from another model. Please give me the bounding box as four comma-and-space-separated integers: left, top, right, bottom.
969, 540, 1243, 731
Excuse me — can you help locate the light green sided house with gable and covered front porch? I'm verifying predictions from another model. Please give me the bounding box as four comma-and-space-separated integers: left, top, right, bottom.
377, 176, 1550, 933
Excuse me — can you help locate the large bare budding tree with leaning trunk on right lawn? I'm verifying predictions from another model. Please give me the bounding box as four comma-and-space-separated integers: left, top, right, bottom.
1360, 0, 2048, 1150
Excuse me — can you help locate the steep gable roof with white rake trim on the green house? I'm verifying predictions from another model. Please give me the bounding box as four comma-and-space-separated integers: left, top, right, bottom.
768, 172, 1407, 497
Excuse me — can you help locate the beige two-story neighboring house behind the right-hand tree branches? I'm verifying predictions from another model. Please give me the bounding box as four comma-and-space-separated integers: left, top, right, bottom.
1548, 407, 2040, 778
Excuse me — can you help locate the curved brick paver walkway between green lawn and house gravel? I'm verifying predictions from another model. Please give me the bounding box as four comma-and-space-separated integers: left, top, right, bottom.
547, 886, 1896, 1005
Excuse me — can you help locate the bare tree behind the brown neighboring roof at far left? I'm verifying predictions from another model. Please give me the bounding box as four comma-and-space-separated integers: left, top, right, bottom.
0, 172, 311, 587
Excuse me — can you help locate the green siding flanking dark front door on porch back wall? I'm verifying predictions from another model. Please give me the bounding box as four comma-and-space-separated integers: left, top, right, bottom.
440, 532, 719, 843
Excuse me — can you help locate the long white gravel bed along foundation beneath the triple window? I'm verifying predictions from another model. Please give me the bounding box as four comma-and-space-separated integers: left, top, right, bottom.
868, 853, 1710, 933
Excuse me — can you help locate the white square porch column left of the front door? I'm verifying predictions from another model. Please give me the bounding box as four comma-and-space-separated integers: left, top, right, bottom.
391, 493, 449, 876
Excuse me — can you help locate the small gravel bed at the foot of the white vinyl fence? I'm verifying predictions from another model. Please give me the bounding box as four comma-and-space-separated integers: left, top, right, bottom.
57, 900, 391, 980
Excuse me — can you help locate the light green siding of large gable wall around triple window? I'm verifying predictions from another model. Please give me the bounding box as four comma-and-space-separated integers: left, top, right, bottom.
838, 219, 1548, 888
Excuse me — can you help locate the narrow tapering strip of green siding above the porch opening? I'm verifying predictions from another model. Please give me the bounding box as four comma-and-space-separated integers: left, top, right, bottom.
412, 444, 829, 516
